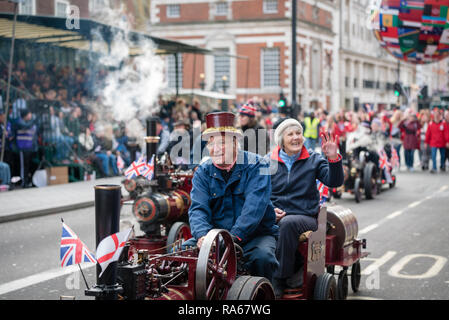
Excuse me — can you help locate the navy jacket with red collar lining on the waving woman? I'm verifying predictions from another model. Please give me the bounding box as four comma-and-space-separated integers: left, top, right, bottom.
270, 147, 344, 216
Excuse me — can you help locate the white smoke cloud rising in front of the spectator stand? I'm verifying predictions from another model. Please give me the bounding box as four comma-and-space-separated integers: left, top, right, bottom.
86, 4, 166, 127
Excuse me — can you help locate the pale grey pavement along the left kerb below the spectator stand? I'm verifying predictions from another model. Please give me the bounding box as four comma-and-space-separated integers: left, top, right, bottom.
0, 176, 127, 223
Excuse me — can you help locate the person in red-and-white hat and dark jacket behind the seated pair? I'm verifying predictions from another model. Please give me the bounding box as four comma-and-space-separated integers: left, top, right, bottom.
239, 100, 270, 156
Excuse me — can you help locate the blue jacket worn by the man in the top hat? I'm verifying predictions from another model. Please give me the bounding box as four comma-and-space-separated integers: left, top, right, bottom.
189, 151, 278, 243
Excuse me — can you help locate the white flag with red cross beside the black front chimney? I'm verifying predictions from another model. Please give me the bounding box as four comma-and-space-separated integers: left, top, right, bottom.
97, 228, 132, 277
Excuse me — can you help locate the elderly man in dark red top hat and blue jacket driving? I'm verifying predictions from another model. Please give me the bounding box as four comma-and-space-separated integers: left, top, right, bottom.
183, 112, 278, 281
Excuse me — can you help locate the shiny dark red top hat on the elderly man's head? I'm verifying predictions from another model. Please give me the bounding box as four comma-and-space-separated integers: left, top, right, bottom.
203, 112, 243, 140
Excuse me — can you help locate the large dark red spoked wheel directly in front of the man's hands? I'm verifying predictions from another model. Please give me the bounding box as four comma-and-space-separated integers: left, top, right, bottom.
195, 229, 237, 300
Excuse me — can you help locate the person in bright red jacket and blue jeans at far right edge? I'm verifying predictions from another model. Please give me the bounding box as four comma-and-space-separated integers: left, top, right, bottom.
426, 108, 449, 173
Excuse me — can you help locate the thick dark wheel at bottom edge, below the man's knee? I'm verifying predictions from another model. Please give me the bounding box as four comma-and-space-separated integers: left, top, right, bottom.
226, 276, 275, 301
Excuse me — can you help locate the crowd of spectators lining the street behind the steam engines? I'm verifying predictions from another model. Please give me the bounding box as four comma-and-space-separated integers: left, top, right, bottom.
0, 61, 449, 187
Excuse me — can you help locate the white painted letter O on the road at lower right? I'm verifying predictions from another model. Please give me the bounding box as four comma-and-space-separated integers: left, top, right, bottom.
388, 254, 447, 279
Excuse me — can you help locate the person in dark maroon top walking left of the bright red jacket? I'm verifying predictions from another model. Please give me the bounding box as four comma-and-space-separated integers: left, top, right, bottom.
399, 109, 421, 171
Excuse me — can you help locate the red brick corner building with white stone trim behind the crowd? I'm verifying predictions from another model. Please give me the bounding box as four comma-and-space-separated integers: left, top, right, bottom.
150, 0, 339, 110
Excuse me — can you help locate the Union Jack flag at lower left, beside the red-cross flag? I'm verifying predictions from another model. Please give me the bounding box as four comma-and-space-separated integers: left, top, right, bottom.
61, 222, 97, 267
